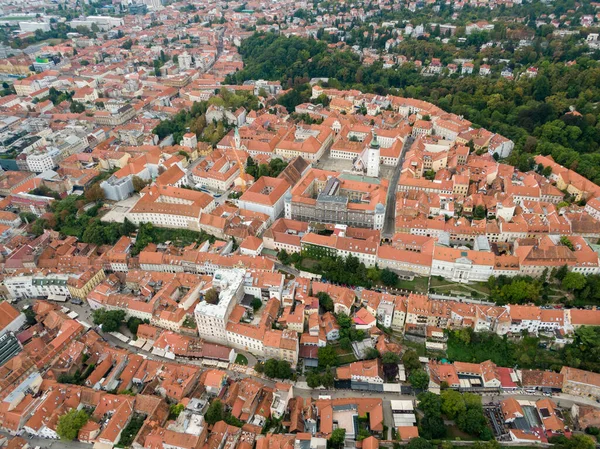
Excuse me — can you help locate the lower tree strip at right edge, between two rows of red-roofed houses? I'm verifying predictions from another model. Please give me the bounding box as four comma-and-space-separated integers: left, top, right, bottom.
447, 326, 600, 372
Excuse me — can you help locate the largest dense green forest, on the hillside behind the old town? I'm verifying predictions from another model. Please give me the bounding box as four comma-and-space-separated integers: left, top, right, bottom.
226, 28, 600, 183
